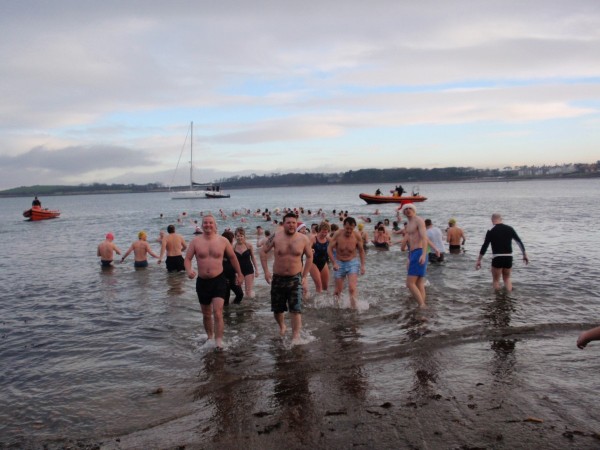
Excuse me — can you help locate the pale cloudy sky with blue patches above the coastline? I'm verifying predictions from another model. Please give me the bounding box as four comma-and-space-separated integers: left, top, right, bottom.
0, 0, 600, 189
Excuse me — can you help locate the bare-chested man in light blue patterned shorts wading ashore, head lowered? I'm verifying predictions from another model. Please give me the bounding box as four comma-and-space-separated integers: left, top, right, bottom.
327, 217, 365, 308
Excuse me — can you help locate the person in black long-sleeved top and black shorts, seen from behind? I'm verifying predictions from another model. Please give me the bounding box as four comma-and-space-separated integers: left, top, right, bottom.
475, 213, 529, 292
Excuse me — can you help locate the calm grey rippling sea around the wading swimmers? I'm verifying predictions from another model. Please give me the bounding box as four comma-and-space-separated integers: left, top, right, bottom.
0, 180, 600, 446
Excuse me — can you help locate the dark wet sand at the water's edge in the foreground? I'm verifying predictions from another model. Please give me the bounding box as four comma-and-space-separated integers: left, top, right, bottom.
37, 328, 600, 449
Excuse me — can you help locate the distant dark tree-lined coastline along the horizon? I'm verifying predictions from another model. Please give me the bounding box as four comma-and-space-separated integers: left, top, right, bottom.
0, 164, 600, 198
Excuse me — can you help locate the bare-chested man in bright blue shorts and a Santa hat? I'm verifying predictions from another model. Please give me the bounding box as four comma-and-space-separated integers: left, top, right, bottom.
400, 203, 429, 308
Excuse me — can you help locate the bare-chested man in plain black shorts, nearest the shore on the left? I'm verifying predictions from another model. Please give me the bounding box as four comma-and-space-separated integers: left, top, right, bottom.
184, 214, 244, 351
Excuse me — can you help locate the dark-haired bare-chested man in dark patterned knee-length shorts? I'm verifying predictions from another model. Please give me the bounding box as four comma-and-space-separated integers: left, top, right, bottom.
260, 212, 313, 343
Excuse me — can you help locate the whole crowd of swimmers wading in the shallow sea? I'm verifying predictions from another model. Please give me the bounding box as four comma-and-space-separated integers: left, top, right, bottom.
91, 203, 600, 351
